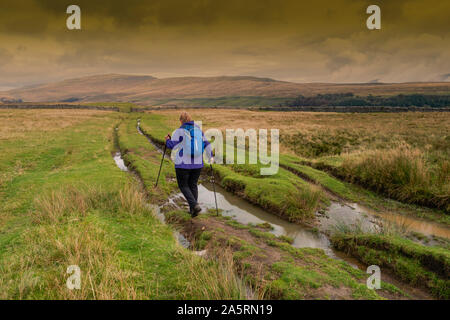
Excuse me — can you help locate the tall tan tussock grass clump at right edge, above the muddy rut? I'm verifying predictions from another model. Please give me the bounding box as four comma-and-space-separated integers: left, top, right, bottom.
341, 145, 450, 212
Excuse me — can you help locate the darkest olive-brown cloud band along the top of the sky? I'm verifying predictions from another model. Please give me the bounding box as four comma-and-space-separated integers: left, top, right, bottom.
0, 0, 450, 33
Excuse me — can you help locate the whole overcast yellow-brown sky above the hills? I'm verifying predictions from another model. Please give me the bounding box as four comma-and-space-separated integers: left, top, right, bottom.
0, 0, 450, 89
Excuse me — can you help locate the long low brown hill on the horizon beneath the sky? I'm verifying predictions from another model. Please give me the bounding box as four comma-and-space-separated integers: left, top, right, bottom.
0, 74, 450, 105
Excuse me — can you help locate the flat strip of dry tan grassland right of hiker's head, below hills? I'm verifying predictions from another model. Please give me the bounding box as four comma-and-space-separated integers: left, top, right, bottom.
152, 109, 450, 156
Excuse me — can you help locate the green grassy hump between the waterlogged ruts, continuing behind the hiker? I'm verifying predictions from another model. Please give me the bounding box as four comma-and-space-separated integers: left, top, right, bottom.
140, 114, 326, 223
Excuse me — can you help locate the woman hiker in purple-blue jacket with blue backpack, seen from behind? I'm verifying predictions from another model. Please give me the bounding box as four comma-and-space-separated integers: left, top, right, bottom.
166, 112, 214, 218
